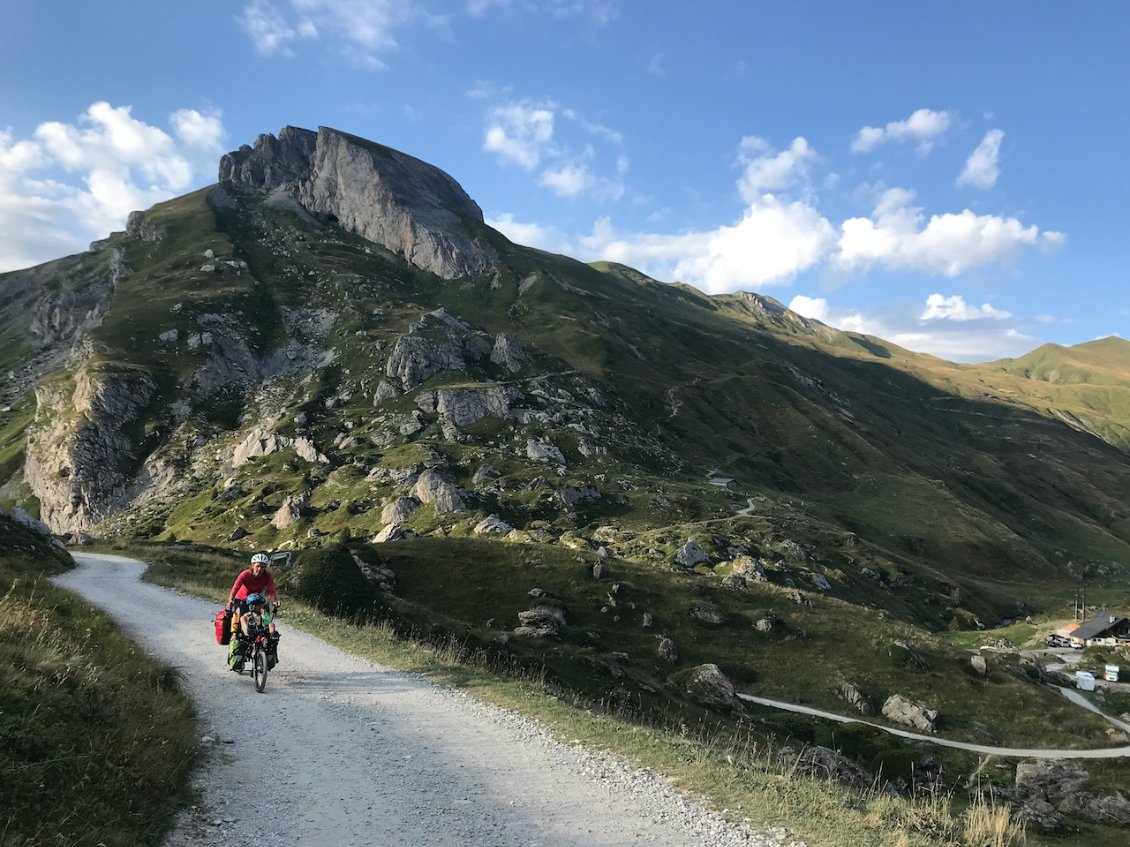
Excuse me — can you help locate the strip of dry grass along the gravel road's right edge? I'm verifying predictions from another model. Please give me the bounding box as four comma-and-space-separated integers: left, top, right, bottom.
125, 548, 1027, 847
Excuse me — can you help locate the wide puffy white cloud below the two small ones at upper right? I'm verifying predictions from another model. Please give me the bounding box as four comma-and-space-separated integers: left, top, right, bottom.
833, 189, 1063, 277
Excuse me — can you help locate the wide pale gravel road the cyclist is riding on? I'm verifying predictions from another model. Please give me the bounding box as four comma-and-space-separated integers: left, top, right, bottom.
57, 553, 802, 847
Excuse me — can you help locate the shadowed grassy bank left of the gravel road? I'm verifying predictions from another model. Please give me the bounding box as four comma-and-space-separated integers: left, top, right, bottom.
0, 518, 197, 847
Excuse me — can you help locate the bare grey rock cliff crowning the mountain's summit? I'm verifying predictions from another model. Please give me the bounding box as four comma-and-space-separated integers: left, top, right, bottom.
219, 126, 495, 279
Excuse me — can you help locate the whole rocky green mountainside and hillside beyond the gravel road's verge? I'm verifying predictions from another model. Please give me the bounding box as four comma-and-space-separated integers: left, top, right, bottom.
0, 126, 1130, 844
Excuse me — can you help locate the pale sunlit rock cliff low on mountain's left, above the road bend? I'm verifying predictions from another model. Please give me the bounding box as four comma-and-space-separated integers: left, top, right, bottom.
24, 366, 157, 533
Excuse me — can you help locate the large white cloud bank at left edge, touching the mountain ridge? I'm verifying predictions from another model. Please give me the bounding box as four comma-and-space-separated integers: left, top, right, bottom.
0, 103, 224, 271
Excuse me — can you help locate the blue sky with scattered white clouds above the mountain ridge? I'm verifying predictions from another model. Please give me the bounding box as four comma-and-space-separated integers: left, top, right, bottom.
0, 0, 1130, 361
